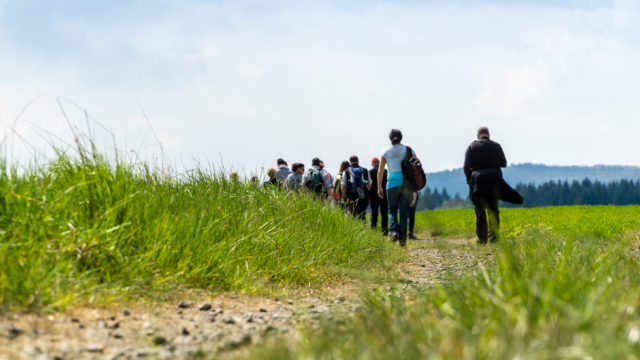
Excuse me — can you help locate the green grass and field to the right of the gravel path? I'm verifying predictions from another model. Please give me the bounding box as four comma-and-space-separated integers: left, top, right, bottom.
252, 206, 640, 359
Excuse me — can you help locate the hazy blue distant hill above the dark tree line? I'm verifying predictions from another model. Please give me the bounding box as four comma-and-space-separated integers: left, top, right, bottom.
427, 164, 640, 198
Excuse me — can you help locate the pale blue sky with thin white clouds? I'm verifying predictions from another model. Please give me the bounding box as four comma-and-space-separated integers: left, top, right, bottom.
0, 0, 640, 173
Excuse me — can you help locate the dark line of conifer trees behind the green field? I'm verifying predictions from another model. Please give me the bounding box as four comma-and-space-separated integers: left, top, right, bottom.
417, 178, 640, 210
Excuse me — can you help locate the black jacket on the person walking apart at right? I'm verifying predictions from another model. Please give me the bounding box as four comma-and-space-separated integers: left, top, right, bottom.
464, 137, 523, 204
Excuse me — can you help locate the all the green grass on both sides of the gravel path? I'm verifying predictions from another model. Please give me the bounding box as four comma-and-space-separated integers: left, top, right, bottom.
7, 148, 640, 359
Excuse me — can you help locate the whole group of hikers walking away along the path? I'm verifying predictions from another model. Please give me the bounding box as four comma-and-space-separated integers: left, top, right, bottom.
264, 127, 523, 246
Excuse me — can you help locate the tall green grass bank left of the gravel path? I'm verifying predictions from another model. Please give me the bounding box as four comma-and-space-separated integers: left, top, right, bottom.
0, 148, 400, 309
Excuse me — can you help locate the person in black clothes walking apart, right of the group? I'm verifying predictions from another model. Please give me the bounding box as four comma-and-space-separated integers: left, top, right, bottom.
463, 126, 522, 244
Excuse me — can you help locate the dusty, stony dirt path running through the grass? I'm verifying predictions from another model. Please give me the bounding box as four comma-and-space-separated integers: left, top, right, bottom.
0, 235, 493, 360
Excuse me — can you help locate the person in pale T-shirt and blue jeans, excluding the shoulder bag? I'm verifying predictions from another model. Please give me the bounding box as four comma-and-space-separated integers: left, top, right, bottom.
378, 129, 415, 246
